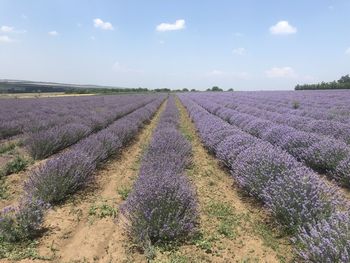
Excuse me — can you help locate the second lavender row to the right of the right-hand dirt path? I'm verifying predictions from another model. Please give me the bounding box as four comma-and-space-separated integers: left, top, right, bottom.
193, 98, 350, 188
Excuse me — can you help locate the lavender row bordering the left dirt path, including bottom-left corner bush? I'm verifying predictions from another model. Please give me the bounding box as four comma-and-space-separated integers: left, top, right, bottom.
0, 97, 164, 242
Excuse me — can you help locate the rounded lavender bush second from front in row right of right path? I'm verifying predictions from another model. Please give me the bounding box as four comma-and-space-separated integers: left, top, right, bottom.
263, 173, 341, 233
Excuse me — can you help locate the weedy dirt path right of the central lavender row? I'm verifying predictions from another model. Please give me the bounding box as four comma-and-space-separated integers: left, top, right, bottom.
156, 98, 292, 262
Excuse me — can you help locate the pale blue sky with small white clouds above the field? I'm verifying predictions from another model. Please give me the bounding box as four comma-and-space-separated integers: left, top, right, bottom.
0, 0, 350, 90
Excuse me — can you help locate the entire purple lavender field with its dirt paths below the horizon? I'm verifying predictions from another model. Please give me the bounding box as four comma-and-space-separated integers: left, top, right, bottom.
0, 91, 350, 262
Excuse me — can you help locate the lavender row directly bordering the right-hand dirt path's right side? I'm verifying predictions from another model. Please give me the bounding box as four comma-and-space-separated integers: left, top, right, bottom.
180, 96, 350, 262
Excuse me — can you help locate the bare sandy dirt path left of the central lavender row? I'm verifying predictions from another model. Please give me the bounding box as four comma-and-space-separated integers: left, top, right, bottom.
6, 100, 165, 263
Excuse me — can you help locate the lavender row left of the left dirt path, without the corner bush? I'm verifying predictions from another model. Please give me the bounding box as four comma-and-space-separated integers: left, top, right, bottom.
25, 98, 163, 203
